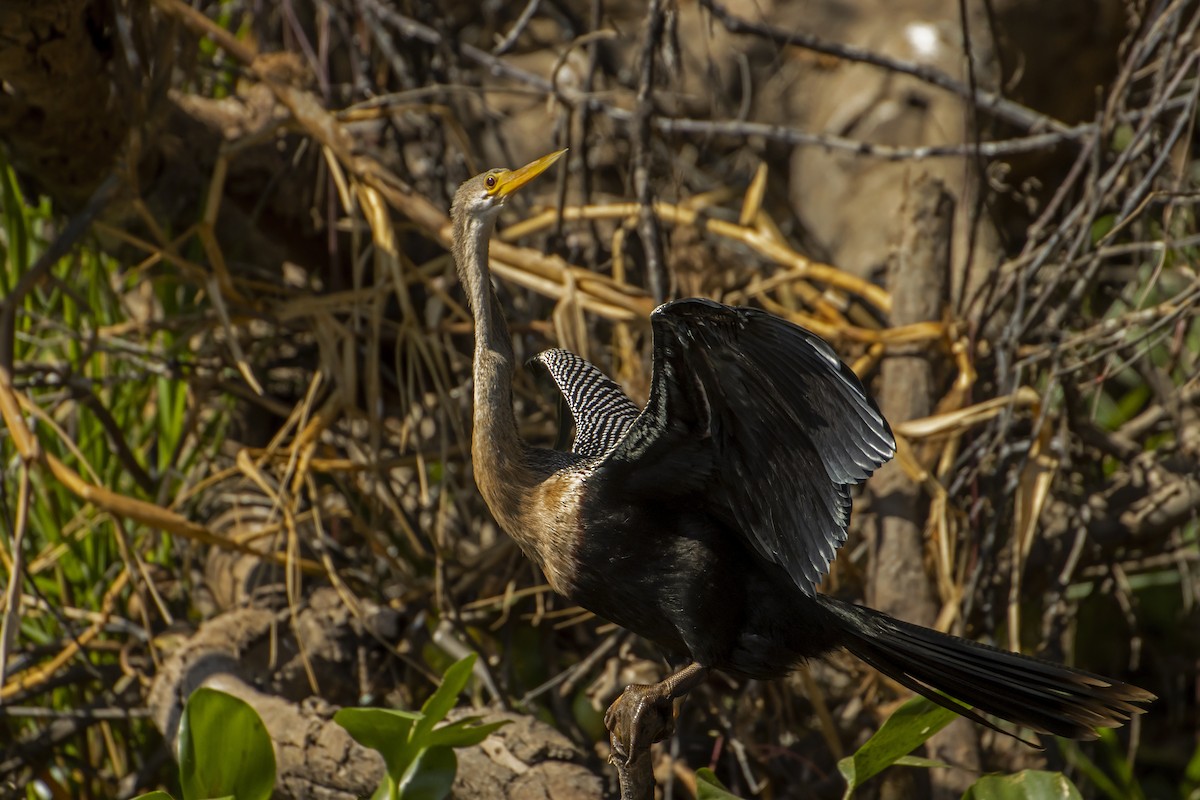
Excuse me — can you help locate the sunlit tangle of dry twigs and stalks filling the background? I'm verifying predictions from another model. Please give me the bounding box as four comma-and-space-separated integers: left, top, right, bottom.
0, 0, 1200, 800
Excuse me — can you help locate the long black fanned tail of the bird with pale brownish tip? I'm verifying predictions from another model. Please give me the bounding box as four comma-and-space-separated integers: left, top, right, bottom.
822, 596, 1154, 741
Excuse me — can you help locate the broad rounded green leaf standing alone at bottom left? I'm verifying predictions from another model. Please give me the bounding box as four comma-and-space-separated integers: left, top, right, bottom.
179, 688, 275, 800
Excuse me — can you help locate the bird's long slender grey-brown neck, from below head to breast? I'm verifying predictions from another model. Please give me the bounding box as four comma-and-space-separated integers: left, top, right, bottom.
454, 207, 530, 520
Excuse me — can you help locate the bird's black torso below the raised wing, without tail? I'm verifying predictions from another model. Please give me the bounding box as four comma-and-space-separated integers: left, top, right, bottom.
570, 476, 838, 679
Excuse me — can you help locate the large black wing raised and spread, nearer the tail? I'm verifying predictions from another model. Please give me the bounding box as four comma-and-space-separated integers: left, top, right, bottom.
601, 299, 895, 594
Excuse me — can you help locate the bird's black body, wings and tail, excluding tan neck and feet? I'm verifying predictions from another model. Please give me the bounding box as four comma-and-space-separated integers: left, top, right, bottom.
525, 300, 1150, 738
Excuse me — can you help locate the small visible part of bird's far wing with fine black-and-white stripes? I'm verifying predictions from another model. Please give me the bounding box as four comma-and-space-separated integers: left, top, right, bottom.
530, 349, 641, 456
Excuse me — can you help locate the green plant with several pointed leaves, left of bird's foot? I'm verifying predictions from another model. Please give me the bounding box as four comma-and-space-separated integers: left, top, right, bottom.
334, 654, 508, 800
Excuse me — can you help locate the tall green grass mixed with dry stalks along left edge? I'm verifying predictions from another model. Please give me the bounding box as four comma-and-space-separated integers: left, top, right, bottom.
0, 156, 213, 798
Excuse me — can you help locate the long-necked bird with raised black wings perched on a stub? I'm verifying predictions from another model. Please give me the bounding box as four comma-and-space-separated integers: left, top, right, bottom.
450, 150, 1156, 763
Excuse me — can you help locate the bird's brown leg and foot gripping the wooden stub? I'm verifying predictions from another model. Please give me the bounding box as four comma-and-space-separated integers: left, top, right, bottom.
604, 663, 708, 763
